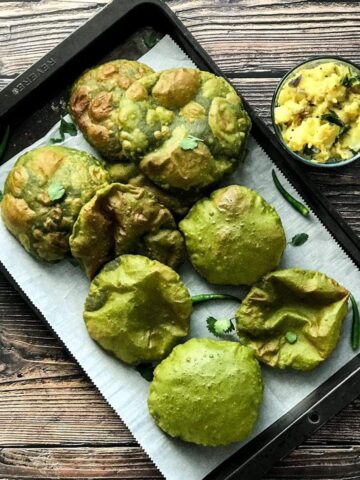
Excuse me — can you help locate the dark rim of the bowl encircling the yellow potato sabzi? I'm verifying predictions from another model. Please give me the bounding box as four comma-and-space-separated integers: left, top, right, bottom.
271, 56, 360, 168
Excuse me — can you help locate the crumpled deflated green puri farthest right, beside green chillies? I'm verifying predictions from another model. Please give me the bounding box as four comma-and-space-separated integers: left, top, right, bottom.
236, 268, 349, 370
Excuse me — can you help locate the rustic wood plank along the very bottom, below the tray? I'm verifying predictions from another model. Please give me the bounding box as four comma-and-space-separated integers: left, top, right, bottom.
0, 447, 360, 480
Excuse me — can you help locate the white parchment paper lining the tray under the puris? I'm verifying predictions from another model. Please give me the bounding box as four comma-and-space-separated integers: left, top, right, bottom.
0, 36, 360, 480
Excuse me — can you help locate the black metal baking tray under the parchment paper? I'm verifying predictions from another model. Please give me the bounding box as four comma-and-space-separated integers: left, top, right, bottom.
0, 0, 360, 480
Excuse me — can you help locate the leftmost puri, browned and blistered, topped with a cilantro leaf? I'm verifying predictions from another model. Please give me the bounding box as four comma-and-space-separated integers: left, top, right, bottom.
1, 146, 108, 262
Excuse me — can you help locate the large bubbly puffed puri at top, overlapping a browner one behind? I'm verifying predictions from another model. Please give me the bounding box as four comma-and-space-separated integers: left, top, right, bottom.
118, 68, 251, 191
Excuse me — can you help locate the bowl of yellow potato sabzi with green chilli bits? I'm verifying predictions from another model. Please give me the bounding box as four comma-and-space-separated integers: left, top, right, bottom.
271, 56, 360, 168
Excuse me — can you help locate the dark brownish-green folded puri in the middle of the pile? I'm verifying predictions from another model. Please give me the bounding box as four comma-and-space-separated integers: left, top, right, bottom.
70, 183, 185, 278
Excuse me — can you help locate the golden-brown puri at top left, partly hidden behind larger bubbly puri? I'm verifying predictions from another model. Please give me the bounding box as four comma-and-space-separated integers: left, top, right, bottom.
69, 60, 153, 161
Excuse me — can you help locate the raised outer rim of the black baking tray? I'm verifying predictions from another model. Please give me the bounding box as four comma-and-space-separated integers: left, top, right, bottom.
0, 0, 360, 480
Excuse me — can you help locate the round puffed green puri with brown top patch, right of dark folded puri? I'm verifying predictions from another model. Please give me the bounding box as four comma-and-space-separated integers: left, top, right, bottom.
179, 185, 286, 285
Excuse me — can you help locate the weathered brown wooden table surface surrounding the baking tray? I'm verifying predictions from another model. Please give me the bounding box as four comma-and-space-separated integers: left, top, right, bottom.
0, 0, 360, 480
